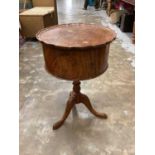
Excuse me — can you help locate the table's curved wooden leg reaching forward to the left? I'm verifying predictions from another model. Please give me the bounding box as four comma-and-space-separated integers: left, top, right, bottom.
53, 99, 75, 130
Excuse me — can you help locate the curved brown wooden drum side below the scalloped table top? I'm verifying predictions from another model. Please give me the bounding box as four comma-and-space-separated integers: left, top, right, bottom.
43, 44, 109, 80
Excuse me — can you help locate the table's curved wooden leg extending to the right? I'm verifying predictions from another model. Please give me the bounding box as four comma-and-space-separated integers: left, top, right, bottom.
81, 94, 107, 119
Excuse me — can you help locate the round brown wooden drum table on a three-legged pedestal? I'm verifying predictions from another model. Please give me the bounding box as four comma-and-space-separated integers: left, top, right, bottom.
36, 23, 116, 130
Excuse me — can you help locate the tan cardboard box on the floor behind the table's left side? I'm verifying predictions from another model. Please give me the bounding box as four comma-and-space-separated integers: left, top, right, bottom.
19, 7, 57, 38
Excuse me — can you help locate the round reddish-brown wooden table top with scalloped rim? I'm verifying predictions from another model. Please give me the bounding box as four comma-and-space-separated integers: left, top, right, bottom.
36, 23, 116, 48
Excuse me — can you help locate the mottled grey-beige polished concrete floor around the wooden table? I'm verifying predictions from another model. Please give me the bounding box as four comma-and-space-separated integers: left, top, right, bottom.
19, 0, 135, 155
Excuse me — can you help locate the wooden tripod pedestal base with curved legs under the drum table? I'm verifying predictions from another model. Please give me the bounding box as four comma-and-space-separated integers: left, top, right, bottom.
53, 81, 107, 130
